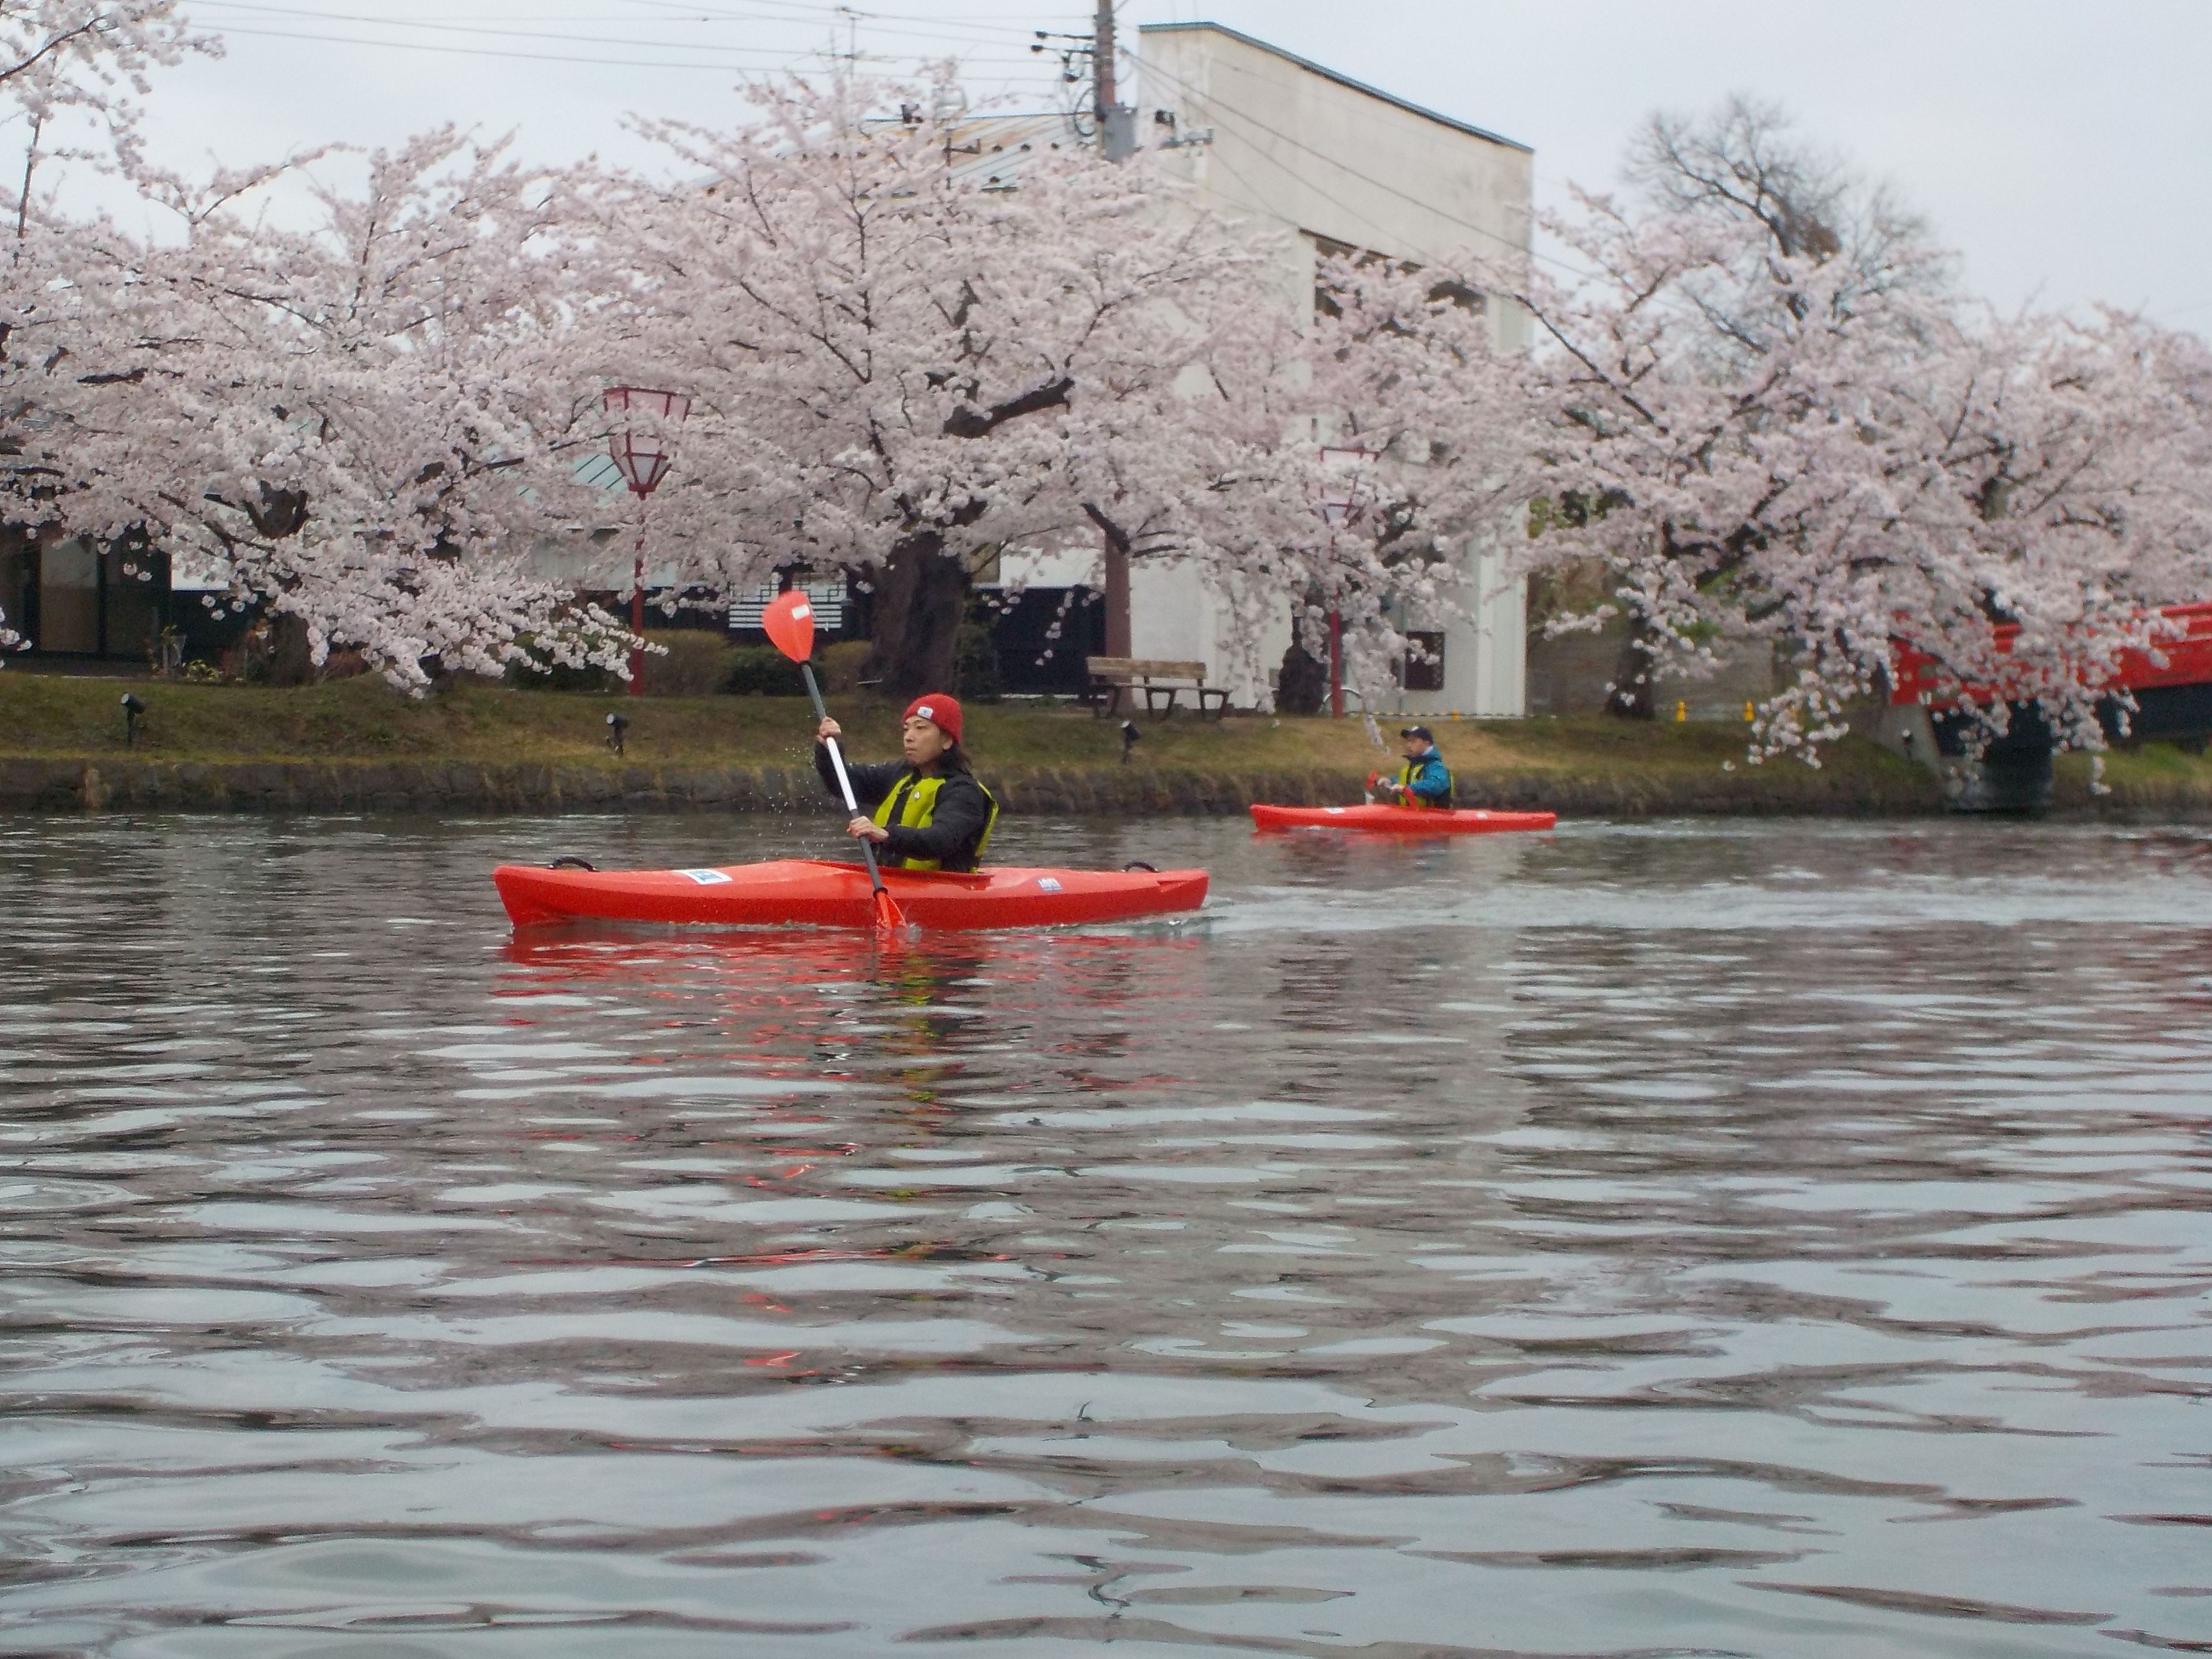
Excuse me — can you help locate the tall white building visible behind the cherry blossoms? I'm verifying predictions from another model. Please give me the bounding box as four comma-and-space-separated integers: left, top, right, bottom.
1075, 22, 1535, 717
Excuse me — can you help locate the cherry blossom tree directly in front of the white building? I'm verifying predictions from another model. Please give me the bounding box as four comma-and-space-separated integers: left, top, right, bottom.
1044, 243, 1529, 701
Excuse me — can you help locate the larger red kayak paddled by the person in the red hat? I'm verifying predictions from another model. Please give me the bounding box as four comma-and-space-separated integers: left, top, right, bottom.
491, 858, 1205, 929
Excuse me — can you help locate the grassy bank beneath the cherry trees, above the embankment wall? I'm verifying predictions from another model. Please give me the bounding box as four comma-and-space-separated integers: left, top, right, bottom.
0, 668, 1973, 816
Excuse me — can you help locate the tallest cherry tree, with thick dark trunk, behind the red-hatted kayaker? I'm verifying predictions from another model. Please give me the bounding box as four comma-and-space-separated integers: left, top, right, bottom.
595, 80, 1292, 694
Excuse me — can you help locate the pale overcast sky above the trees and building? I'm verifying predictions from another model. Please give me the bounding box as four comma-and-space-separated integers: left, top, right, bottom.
116, 0, 2212, 330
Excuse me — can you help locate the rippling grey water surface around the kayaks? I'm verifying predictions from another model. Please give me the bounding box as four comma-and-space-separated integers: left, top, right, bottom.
0, 818, 2212, 1659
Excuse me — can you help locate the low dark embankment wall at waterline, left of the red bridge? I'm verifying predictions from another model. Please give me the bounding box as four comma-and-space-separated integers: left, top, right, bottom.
0, 759, 1942, 818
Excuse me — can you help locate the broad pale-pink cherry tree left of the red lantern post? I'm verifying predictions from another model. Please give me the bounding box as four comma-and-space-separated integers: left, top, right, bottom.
18, 130, 626, 686
